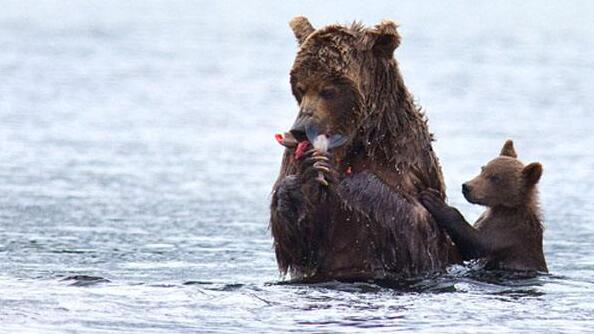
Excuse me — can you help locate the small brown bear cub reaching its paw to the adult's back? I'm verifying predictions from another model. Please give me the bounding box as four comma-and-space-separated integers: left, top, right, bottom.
420, 140, 548, 272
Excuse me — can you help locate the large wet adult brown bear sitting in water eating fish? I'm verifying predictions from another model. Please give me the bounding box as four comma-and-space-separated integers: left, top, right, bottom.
270, 17, 458, 281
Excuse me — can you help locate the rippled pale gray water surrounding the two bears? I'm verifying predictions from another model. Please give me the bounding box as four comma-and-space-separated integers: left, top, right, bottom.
0, 0, 594, 333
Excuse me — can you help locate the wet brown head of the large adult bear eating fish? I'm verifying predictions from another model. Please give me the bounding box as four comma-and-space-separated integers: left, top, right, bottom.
289, 17, 400, 150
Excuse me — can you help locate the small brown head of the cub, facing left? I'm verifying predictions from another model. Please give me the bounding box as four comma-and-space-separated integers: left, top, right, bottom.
462, 140, 542, 208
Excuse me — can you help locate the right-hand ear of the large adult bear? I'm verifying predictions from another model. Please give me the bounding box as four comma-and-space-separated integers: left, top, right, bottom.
363, 20, 400, 58
